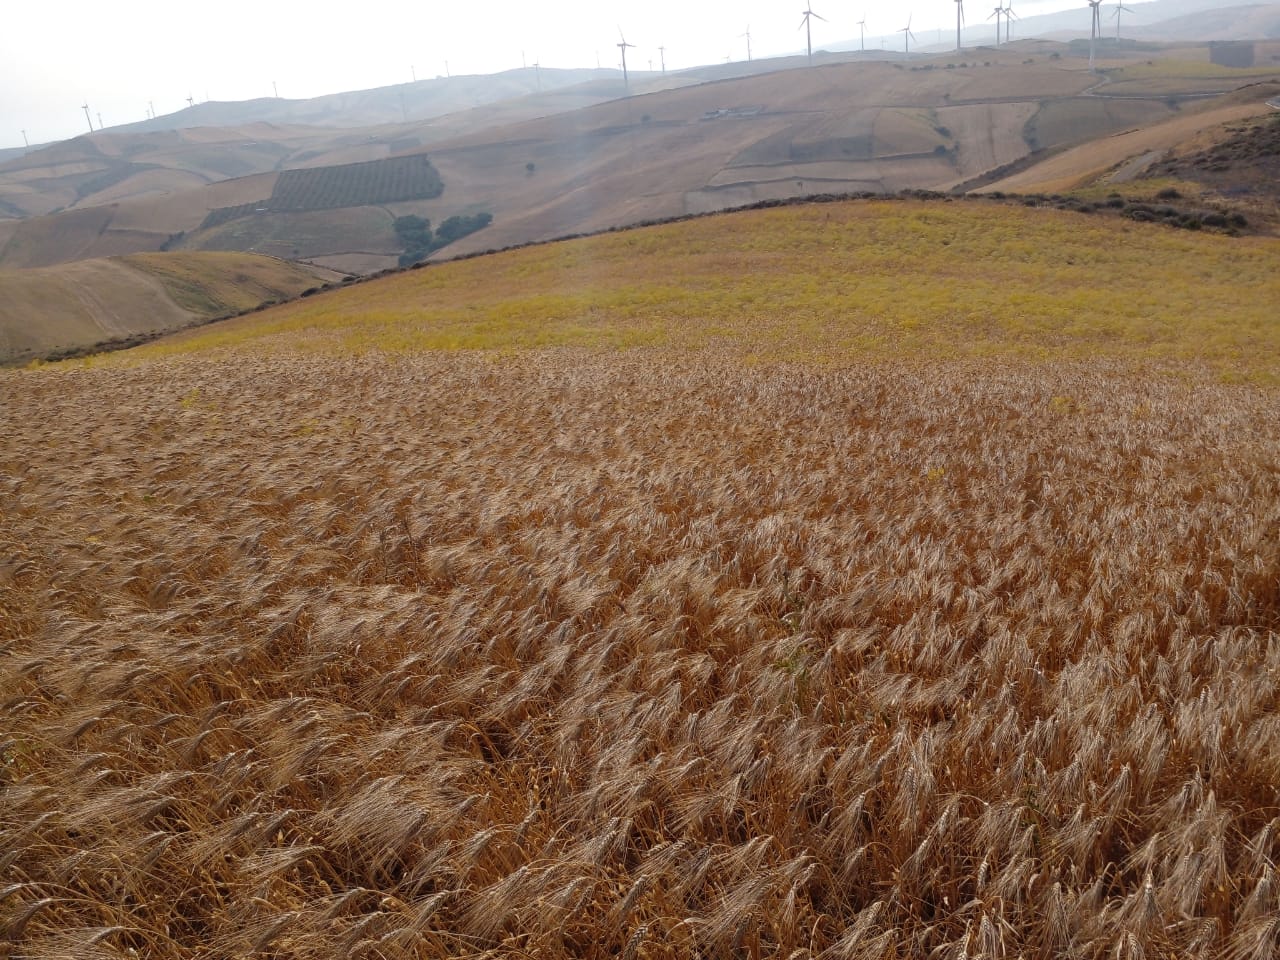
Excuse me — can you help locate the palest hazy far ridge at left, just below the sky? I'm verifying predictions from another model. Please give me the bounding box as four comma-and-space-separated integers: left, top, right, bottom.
0, 70, 675, 225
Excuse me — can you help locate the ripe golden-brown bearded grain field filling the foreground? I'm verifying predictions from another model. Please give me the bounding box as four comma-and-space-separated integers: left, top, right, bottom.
0, 346, 1280, 960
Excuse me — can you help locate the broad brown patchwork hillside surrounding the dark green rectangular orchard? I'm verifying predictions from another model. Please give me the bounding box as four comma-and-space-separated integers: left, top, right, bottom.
0, 47, 1192, 271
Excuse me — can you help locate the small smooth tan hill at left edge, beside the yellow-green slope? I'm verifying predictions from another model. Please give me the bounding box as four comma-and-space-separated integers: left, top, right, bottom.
0, 253, 334, 364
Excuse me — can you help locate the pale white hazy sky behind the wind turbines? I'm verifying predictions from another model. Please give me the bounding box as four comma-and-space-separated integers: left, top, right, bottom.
0, 0, 1133, 147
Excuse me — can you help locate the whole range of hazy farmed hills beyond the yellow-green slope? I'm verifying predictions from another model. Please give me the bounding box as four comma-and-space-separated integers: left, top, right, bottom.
0, 24, 1280, 285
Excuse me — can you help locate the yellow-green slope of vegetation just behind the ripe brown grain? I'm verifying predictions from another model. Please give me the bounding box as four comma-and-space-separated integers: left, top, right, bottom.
135, 201, 1280, 381
